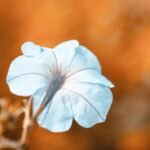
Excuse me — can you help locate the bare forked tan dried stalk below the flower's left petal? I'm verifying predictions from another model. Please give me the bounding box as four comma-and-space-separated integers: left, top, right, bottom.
0, 97, 43, 150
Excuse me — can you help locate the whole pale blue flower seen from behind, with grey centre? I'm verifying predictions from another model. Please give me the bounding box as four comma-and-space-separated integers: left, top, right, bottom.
7, 40, 113, 132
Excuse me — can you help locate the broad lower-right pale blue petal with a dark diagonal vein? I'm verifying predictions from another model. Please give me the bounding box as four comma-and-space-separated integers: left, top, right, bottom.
63, 83, 112, 127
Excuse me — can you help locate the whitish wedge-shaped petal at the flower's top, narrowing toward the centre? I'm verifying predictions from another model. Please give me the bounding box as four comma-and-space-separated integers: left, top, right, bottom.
53, 40, 79, 70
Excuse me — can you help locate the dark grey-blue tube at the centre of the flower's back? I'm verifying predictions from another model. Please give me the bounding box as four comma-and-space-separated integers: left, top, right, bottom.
42, 70, 65, 107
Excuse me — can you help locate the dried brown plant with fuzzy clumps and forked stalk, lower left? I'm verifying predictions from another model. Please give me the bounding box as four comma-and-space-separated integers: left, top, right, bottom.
0, 97, 42, 150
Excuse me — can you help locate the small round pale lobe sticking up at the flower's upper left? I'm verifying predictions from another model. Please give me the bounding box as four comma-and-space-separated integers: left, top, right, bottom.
21, 42, 42, 56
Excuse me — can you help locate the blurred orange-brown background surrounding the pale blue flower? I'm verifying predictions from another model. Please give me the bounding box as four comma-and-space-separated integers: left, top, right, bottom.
0, 0, 150, 150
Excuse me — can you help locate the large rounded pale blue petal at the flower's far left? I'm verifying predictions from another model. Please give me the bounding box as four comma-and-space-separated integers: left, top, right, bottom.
7, 52, 55, 96
